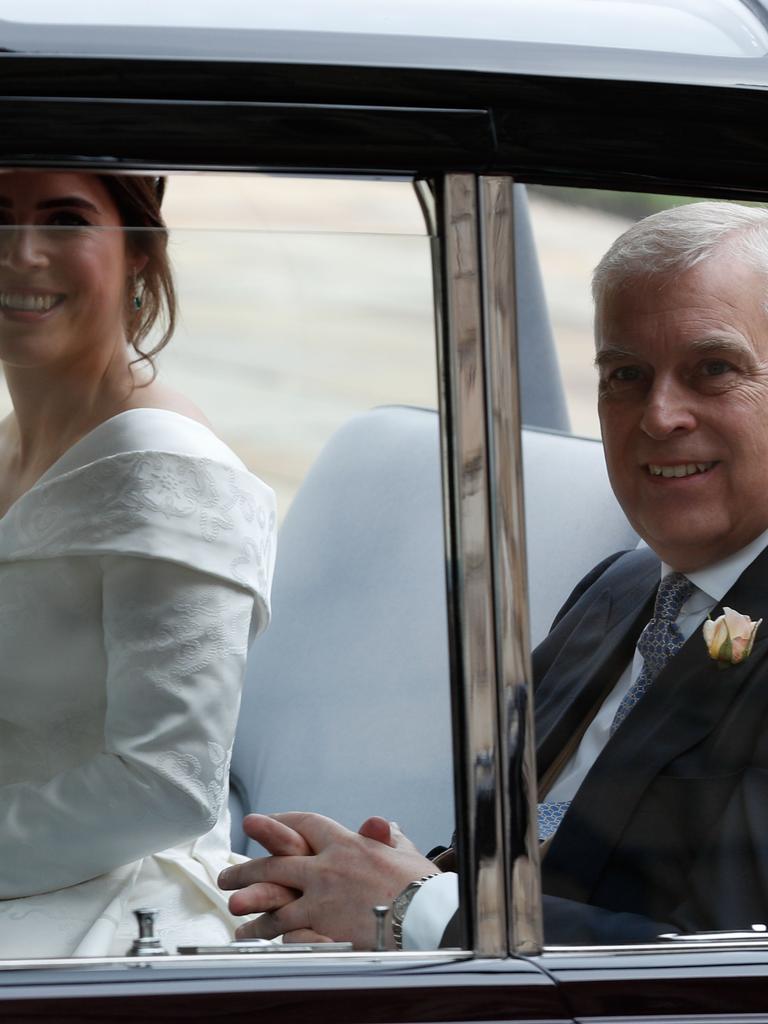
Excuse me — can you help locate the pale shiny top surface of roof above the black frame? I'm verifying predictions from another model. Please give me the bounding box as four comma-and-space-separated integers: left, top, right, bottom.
0, 0, 768, 72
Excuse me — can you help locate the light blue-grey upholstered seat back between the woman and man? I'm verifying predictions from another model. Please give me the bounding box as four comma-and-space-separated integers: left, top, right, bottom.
231, 407, 637, 852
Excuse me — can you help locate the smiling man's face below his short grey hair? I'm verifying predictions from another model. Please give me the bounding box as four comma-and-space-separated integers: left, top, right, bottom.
595, 228, 768, 571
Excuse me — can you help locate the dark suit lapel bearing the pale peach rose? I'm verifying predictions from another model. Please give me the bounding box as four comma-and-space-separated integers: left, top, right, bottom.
545, 549, 768, 900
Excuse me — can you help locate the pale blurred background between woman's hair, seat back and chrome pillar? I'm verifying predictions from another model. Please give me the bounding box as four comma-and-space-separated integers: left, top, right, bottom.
161, 177, 436, 517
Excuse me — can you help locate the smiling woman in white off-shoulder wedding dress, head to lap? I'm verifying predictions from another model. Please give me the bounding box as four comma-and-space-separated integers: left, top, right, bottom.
0, 172, 274, 957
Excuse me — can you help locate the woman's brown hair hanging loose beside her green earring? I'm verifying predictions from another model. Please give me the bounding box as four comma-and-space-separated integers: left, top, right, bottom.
98, 174, 176, 377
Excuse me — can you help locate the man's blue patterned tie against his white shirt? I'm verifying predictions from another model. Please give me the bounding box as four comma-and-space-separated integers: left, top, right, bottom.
539, 572, 693, 843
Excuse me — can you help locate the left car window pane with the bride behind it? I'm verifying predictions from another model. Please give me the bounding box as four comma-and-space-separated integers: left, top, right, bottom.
0, 172, 454, 961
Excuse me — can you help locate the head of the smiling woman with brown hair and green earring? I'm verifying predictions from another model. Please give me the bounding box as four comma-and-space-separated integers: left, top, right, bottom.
0, 172, 175, 385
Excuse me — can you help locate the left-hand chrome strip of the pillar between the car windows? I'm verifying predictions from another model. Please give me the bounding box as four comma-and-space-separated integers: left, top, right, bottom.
435, 174, 508, 956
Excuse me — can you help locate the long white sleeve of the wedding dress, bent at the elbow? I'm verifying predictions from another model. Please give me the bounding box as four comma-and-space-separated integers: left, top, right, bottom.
0, 556, 253, 899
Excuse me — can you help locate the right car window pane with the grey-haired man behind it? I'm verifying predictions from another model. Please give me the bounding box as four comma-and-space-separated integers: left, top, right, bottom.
526, 187, 768, 945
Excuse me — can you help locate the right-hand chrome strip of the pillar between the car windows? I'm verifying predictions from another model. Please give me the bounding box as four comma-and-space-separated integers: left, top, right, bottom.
479, 176, 543, 954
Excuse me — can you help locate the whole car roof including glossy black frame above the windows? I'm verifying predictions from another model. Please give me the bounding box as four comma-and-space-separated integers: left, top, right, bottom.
0, 0, 768, 199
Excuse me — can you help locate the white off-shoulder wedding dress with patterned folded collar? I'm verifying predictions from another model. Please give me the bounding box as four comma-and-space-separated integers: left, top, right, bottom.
0, 410, 275, 958
